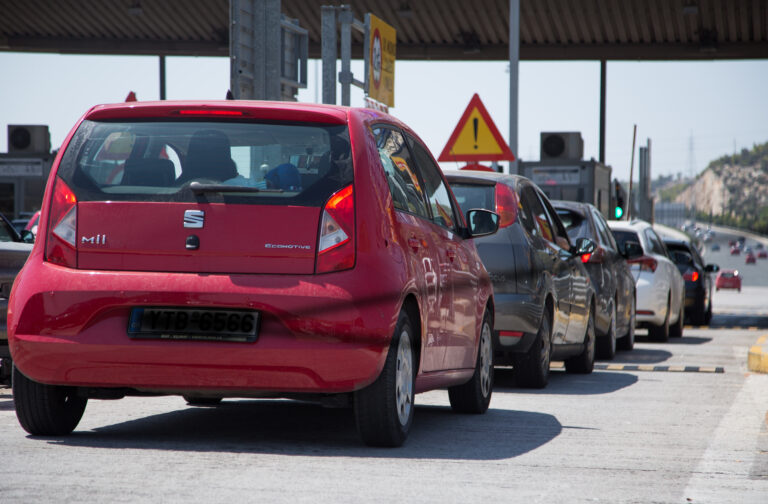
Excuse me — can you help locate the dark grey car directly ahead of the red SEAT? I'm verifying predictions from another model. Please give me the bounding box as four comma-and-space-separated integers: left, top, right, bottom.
446, 171, 596, 388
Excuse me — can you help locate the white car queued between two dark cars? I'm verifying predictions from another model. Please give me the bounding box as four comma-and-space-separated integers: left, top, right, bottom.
608, 220, 685, 341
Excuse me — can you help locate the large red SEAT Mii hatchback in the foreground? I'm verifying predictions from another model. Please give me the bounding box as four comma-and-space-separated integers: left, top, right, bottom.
8, 101, 498, 446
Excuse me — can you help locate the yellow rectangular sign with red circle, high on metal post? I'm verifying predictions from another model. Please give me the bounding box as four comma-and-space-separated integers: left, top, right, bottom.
365, 14, 397, 107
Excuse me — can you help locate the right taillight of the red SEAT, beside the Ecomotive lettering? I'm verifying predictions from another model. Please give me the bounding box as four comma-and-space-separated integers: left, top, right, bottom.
316, 185, 355, 273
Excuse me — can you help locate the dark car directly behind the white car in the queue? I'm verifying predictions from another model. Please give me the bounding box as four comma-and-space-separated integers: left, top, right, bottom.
552, 201, 642, 359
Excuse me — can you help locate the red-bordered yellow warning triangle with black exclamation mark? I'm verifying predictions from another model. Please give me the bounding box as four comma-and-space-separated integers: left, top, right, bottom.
438, 93, 515, 161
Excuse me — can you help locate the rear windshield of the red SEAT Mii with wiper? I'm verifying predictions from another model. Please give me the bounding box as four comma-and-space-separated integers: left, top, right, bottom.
58, 121, 353, 206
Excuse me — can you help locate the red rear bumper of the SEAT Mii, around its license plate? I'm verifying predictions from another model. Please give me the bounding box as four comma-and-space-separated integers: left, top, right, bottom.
9, 263, 400, 395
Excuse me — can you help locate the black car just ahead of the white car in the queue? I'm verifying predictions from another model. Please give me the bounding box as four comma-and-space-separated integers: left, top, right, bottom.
663, 237, 720, 325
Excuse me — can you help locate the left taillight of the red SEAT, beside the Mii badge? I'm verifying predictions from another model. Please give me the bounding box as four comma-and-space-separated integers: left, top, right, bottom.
45, 177, 77, 268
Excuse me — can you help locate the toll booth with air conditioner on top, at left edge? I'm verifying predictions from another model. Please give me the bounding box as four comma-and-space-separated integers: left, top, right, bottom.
0, 125, 54, 219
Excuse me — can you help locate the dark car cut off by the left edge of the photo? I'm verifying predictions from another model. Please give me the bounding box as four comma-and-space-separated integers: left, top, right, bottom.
0, 214, 34, 384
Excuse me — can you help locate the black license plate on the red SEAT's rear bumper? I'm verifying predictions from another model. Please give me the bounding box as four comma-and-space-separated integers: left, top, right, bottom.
128, 307, 259, 342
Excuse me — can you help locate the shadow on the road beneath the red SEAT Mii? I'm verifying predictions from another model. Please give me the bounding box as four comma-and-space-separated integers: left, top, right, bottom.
46, 397, 562, 460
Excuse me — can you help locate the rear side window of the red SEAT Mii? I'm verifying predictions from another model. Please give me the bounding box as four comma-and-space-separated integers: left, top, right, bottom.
373, 126, 429, 219
